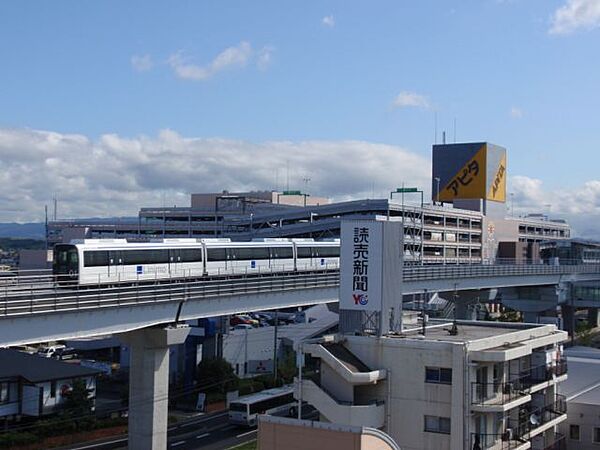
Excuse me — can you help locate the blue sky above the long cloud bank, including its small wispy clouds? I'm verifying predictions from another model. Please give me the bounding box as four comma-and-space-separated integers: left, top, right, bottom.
0, 0, 600, 234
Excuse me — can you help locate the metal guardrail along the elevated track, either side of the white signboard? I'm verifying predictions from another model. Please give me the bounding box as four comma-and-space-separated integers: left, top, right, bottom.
0, 264, 600, 317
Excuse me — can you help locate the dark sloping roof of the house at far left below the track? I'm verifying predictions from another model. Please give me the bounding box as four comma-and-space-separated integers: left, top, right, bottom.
0, 348, 101, 383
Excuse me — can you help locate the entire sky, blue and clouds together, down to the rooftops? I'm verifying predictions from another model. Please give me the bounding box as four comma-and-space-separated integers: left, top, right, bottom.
0, 0, 600, 237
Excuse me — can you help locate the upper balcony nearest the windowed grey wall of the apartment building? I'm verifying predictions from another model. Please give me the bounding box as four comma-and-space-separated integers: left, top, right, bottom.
471, 380, 531, 412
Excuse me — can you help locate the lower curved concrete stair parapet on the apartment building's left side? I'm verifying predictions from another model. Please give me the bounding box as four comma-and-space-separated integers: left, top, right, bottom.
294, 379, 385, 428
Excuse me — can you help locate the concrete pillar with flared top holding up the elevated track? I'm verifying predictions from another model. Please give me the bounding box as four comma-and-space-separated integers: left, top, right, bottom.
123, 326, 189, 450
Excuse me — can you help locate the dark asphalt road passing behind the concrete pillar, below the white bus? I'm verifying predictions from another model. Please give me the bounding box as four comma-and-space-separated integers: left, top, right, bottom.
63, 411, 257, 450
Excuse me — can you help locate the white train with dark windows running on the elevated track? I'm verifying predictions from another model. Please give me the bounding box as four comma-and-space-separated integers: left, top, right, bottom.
53, 239, 340, 285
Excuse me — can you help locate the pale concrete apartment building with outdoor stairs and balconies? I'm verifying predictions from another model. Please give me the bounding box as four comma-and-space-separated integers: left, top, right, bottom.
295, 321, 567, 450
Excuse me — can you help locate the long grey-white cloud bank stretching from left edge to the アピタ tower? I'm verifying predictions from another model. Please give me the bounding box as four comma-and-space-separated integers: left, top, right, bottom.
0, 129, 430, 222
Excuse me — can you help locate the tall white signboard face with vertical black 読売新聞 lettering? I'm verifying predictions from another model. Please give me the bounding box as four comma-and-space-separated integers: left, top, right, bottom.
340, 220, 383, 311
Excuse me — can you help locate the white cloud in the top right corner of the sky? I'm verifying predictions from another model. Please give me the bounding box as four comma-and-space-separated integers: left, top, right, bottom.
549, 0, 600, 34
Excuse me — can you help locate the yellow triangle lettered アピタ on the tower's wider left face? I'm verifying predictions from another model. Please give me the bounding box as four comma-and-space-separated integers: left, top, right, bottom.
439, 145, 486, 202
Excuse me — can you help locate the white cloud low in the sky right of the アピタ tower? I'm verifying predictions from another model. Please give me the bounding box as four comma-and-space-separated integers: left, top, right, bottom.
510, 176, 600, 239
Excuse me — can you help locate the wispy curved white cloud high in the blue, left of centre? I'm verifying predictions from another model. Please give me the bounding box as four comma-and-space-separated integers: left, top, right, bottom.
168, 41, 254, 81
